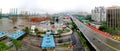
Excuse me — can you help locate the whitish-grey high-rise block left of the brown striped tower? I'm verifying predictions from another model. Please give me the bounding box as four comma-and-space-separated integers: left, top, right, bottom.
91, 7, 106, 22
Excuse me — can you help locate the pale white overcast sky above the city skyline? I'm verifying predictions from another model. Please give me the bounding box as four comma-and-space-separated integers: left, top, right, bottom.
0, 0, 120, 13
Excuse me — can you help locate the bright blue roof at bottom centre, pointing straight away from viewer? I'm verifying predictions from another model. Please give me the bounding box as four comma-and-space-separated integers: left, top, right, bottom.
41, 34, 55, 49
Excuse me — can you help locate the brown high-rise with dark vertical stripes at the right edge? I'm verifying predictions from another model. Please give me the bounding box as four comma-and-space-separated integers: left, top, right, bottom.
106, 6, 120, 28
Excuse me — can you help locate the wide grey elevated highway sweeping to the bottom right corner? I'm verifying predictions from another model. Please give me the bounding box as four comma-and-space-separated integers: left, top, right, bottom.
71, 16, 120, 51
